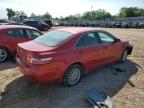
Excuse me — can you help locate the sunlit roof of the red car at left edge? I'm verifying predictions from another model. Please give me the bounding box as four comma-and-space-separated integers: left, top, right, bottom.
0, 25, 35, 30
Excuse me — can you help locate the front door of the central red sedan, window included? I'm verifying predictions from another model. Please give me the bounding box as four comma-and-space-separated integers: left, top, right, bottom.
98, 31, 122, 63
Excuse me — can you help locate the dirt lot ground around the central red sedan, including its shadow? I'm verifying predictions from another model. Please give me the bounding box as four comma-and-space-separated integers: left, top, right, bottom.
0, 28, 144, 108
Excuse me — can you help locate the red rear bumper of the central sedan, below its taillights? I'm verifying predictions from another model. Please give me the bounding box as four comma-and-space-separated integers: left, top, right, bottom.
16, 57, 64, 84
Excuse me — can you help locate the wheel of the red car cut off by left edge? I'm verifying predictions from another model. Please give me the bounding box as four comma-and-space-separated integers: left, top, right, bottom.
0, 47, 8, 63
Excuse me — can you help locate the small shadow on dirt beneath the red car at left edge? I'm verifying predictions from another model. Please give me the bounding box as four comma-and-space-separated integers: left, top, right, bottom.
0, 59, 16, 71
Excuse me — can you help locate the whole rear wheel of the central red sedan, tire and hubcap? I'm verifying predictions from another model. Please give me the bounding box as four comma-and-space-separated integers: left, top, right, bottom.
63, 64, 83, 87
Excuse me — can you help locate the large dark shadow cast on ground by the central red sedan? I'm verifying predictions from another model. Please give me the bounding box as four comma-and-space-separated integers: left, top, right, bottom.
0, 60, 140, 108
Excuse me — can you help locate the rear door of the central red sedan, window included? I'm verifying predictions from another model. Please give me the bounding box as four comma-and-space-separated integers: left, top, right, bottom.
75, 32, 103, 72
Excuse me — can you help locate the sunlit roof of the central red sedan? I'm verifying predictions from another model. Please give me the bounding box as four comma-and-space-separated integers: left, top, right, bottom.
57, 27, 96, 34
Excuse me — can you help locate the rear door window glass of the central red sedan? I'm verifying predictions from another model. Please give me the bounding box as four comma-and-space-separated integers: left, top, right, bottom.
76, 33, 99, 47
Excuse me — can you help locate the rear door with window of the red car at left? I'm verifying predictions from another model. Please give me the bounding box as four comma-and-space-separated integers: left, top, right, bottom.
6, 29, 28, 53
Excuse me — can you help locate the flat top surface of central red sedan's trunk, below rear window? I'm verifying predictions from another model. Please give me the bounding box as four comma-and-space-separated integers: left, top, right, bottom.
18, 41, 54, 52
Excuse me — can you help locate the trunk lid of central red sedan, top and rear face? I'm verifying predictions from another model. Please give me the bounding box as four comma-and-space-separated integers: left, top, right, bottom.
17, 41, 54, 65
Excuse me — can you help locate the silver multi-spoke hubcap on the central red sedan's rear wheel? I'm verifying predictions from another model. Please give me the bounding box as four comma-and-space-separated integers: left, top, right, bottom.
68, 67, 81, 85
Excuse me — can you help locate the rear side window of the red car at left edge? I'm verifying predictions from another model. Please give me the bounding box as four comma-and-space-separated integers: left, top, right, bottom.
7, 30, 25, 38
